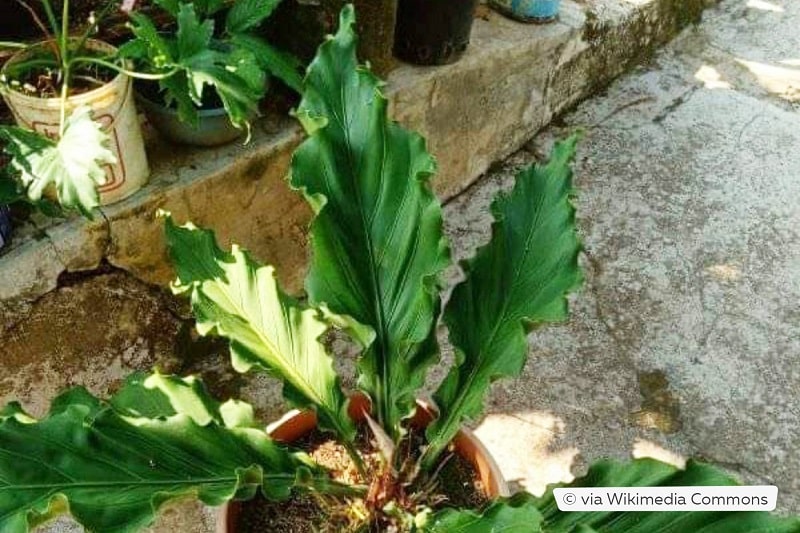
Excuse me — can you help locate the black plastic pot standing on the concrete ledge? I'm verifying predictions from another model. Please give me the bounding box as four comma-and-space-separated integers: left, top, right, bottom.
394, 0, 478, 65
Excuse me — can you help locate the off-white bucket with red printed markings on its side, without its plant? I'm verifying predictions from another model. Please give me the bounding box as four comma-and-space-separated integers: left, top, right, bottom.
0, 40, 150, 205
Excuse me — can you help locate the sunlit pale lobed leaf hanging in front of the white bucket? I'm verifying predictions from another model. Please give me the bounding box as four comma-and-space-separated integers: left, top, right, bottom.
0, 106, 116, 218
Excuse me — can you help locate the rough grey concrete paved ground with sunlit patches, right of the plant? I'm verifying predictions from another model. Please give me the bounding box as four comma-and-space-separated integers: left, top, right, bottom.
447, 0, 800, 512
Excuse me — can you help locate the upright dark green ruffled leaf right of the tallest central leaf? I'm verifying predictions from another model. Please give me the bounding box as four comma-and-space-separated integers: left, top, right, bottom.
423, 137, 581, 470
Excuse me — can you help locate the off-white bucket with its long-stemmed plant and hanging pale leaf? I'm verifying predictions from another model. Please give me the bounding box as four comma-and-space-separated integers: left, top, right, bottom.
0, 0, 155, 213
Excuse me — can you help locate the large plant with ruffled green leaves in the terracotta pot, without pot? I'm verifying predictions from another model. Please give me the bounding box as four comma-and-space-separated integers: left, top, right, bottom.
0, 6, 800, 533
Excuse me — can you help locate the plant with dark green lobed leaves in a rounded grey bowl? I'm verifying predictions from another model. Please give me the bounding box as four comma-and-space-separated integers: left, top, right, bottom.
122, 0, 301, 146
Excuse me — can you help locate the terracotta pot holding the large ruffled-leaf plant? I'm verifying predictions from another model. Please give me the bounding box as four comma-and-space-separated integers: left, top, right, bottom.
217, 395, 511, 533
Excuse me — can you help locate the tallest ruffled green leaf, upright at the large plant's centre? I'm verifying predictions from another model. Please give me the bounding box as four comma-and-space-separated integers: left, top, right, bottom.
291, 6, 449, 433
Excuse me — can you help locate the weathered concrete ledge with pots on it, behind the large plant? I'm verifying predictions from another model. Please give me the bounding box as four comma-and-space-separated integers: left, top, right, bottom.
0, 0, 708, 320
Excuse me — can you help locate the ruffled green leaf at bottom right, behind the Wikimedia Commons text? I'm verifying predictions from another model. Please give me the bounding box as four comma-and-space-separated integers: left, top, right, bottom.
420, 459, 800, 533
